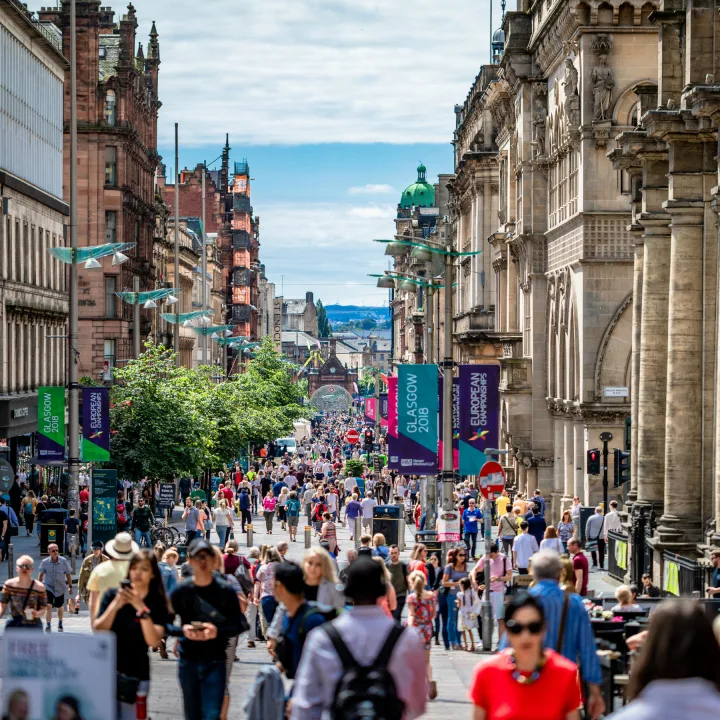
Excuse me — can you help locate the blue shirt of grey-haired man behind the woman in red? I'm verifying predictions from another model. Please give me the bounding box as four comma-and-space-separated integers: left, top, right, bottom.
499, 580, 602, 685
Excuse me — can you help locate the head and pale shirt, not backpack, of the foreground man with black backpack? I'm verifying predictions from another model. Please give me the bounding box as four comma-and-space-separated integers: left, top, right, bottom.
290, 557, 428, 720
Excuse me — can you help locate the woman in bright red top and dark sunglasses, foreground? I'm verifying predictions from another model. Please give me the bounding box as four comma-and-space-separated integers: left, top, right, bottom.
470, 593, 582, 720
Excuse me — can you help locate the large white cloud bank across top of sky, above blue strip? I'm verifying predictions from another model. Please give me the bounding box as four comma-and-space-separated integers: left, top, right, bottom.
40, 0, 500, 147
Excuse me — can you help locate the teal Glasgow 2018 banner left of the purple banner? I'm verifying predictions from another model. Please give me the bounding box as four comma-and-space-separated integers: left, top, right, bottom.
389, 365, 438, 475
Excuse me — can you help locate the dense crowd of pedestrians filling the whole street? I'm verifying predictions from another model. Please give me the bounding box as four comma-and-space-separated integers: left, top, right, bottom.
7, 408, 720, 720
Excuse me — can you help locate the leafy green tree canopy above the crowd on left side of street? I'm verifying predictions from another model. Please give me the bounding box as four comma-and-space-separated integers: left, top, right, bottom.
110, 338, 302, 479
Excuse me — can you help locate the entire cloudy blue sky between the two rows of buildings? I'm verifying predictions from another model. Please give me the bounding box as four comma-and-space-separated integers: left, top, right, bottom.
54, 0, 506, 304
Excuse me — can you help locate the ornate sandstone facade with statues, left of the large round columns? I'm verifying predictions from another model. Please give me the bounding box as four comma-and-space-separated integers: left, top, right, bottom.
451, 0, 658, 520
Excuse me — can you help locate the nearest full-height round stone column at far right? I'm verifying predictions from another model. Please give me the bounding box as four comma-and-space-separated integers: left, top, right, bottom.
658, 200, 704, 542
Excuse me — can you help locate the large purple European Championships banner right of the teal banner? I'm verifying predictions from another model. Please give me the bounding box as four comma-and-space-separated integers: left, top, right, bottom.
459, 365, 500, 475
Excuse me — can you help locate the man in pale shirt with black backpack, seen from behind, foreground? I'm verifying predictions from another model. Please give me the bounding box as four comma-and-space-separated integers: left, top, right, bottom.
291, 556, 428, 720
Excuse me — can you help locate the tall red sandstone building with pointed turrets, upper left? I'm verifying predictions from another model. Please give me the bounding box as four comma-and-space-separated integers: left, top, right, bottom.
38, 0, 160, 379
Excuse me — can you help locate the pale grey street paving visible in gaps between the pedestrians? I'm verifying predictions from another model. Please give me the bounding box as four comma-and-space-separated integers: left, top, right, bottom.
0, 508, 617, 720
